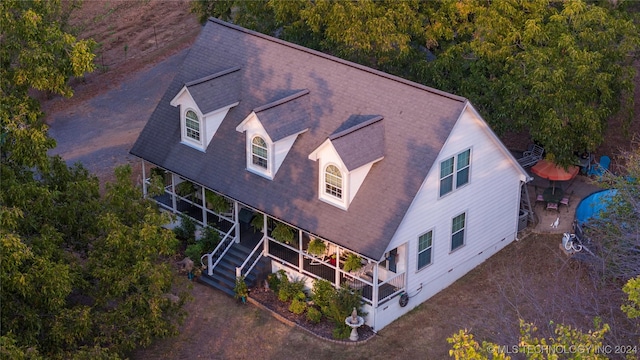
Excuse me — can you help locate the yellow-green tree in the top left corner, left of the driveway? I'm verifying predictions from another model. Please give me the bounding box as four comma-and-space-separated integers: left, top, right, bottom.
0, 0, 94, 167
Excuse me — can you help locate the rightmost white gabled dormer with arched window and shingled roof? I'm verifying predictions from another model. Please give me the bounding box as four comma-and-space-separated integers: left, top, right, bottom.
309, 115, 384, 210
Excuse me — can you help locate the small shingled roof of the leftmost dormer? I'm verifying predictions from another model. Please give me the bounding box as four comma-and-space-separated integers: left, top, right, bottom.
185, 66, 240, 114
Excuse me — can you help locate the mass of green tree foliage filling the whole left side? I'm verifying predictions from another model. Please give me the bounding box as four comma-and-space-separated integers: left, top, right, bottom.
0, 0, 185, 359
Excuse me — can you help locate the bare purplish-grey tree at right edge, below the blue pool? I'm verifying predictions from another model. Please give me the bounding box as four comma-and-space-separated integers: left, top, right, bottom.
585, 139, 640, 281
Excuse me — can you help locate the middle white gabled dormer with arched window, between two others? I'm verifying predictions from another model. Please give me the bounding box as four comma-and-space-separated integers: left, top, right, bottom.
236, 90, 310, 180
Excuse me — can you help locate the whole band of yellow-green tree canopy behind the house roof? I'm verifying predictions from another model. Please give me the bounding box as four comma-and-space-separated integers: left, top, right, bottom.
194, 0, 640, 165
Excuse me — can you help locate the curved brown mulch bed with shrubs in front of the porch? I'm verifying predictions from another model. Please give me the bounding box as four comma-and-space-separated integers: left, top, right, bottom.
249, 289, 375, 342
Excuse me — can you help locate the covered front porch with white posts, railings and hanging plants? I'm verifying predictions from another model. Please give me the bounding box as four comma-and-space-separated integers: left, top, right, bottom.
142, 161, 406, 308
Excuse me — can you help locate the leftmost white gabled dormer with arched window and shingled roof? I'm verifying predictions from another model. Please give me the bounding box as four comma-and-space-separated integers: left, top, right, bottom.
171, 67, 240, 151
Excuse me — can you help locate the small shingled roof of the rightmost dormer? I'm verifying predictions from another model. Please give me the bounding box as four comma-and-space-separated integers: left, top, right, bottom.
329, 116, 384, 171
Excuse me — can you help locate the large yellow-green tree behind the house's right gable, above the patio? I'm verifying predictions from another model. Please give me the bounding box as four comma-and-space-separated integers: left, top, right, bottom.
423, 0, 639, 165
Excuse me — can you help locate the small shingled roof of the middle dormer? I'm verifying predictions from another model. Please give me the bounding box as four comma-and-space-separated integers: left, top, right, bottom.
253, 89, 311, 141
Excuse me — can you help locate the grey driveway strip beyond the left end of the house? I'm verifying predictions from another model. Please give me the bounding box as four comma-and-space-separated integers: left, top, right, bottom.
46, 50, 187, 182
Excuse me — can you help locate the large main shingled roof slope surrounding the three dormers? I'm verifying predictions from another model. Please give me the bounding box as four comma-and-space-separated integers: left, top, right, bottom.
131, 19, 466, 260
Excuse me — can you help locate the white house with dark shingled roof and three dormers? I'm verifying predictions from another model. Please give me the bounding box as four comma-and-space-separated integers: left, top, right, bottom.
131, 19, 530, 330
